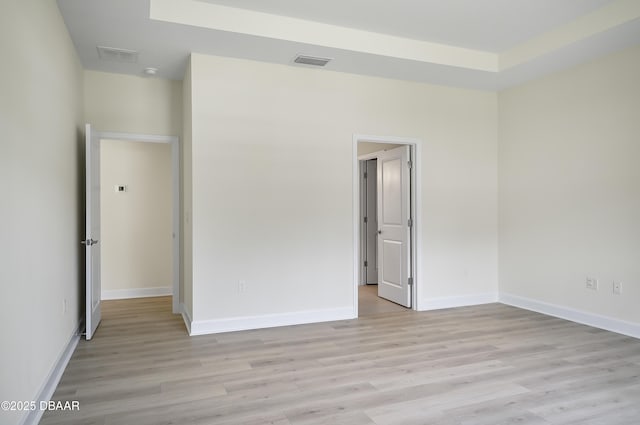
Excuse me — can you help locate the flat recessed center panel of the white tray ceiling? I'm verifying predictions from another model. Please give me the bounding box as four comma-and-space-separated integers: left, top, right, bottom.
202, 0, 611, 53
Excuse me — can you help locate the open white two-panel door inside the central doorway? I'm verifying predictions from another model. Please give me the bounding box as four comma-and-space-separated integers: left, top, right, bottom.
377, 146, 411, 307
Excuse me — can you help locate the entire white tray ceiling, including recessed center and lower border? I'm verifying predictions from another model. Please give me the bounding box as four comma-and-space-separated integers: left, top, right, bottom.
58, 0, 640, 90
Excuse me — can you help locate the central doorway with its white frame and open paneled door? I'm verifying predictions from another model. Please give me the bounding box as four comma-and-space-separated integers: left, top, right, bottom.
354, 135, 419, 315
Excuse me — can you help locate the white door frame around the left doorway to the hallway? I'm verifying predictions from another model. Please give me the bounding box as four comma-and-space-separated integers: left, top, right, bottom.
98, 131, 182, 314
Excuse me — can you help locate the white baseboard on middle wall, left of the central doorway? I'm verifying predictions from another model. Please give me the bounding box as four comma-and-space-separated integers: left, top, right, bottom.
187, 307, 356, 336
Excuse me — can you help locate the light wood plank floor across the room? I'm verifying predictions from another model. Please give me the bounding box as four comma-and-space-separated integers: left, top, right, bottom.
41, 298, 640, 425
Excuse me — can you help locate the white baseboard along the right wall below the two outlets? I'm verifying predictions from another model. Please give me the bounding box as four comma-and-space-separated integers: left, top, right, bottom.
500, 292, 640, 338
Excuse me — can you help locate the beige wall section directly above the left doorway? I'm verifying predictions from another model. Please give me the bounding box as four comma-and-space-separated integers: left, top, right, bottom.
84, 71, 182, 136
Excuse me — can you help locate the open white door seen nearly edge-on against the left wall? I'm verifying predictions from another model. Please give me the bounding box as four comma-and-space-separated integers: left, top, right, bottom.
82, 124, 101, 340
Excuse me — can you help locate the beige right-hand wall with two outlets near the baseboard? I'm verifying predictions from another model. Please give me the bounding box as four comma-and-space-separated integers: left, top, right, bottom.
499, 47, 640, 324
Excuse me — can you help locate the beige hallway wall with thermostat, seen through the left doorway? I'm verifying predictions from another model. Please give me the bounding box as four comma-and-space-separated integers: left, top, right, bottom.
100, 140, 173, 298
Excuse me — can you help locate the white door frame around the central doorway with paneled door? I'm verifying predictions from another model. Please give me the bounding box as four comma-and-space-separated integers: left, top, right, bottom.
352, 134, 422, 317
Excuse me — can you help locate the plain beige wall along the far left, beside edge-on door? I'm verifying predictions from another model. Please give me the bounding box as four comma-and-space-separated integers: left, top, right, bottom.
0, 0, 84, 425
